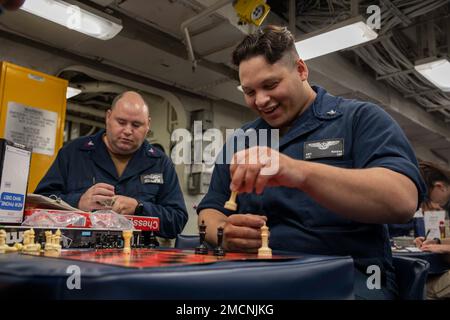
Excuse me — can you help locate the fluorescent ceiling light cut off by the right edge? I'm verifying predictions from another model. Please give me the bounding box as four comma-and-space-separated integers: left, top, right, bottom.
414, 58, 450, 92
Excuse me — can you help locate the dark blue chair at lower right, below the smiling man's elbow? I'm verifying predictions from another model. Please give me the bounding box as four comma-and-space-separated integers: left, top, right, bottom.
392, 256, 430, 300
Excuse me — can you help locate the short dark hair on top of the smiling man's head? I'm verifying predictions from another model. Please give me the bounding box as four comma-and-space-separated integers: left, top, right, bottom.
232, 25, 298, 66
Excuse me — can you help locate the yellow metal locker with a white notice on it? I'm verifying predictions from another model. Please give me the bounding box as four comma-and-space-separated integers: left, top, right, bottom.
0, 62, 67, 192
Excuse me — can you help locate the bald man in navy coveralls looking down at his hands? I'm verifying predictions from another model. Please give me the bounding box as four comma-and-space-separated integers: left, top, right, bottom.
35, 91, 188, 238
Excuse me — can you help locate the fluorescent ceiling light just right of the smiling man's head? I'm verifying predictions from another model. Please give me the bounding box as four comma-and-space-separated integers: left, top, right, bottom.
295, 17, 378, 60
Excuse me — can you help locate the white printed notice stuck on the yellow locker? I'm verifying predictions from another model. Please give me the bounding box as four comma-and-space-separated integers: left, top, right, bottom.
5, 101, 58, 156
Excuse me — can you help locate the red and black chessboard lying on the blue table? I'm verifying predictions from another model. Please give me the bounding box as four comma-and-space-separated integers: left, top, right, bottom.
22, 248, 299, 268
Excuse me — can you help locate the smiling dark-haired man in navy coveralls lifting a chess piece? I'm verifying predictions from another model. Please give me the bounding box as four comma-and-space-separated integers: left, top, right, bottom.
197, 26, 426, 299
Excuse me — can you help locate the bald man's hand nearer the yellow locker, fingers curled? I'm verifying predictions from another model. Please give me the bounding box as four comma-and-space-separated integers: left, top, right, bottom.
78, 183, 115, 211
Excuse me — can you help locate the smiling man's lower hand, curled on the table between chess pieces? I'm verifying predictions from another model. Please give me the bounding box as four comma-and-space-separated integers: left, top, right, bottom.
223, 214, 267, 252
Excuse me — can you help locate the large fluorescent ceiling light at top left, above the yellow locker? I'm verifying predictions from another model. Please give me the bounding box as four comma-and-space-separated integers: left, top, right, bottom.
21, 0, 122, 40
